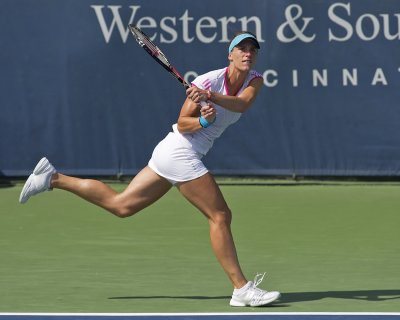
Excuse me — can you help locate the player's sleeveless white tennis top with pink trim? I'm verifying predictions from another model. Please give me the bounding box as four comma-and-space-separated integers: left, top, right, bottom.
172, 67, 262, 155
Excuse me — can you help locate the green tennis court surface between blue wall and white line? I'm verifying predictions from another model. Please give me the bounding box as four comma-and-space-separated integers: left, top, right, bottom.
0, 183, 400, 313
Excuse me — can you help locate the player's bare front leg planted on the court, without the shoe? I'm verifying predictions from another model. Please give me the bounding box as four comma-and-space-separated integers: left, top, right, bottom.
177, 173, 247, 288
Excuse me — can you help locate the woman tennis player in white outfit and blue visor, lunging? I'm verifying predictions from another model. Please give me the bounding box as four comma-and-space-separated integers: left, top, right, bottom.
20, 32, 280, 307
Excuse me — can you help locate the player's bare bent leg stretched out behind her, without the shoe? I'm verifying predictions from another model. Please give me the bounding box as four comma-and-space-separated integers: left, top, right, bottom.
51, 167, 172, 218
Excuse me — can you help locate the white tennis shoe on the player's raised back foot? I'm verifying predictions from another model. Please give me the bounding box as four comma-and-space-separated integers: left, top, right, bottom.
19, 158, 57, 203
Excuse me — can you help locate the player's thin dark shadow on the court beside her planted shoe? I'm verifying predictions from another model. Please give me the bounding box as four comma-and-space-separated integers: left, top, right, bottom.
108, 290, 400, 307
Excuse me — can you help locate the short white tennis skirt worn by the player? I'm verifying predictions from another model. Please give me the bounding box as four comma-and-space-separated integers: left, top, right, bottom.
149, 132, 208, 184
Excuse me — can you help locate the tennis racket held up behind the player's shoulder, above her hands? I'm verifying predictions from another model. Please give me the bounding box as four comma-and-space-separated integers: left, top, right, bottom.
129, 24, 191, 89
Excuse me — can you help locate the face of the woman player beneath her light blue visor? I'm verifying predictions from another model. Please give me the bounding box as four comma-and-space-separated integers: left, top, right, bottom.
228, 40, 258, 71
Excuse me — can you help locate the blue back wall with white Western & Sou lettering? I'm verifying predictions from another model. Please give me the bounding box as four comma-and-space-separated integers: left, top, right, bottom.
0, 0, 400, 176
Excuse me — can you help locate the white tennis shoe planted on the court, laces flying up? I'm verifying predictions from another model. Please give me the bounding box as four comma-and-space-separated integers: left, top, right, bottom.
229, 273, 281, 307
